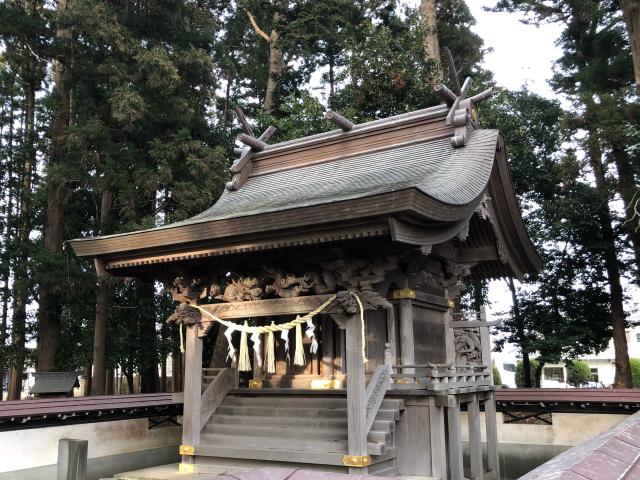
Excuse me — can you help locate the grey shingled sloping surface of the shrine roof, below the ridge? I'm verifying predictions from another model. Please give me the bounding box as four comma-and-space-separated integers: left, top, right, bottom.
182, 130, 499, 227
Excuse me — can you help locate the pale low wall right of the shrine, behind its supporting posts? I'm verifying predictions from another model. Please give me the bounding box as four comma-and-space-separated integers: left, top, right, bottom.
460, 412, 629, 479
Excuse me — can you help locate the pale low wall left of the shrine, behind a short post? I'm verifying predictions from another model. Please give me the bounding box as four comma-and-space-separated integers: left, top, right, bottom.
0, 418, 182, 480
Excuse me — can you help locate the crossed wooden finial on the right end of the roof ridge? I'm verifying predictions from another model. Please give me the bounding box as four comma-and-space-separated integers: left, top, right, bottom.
433, 47, 494, 148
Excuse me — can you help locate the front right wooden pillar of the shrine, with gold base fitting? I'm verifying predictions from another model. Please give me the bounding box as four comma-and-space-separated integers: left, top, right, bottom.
345, 314, 368, 473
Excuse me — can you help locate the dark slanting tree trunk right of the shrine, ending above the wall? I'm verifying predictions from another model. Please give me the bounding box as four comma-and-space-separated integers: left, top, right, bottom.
585, 113, 632, 388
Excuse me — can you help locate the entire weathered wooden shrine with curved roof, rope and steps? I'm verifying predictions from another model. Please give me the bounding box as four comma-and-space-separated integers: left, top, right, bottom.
71, 80, 540, 480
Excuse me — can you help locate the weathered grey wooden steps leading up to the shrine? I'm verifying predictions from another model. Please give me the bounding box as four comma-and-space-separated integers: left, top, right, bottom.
196, 391, 404, 475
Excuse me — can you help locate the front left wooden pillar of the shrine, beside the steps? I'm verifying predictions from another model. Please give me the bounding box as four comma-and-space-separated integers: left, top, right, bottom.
180, 324, 202, 464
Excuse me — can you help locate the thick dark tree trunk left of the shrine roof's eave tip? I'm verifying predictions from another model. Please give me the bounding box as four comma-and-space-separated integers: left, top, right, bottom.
37, 0, 71, 372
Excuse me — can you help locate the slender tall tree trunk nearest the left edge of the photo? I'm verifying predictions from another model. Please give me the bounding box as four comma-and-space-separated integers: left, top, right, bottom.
7, 72, 36, 400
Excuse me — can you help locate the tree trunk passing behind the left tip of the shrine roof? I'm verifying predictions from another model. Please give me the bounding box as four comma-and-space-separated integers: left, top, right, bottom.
91, 189, 113, 395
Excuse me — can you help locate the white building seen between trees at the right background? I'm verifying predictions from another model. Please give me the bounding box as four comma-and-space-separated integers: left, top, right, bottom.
492, 327, 640, 388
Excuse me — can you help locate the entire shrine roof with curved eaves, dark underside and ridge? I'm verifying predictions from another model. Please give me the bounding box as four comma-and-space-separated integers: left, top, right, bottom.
71, 102, 539, 278
